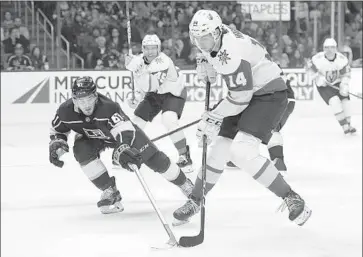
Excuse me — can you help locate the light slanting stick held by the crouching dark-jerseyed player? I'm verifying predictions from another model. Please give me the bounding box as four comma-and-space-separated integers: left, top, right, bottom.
129, 164, 178, 247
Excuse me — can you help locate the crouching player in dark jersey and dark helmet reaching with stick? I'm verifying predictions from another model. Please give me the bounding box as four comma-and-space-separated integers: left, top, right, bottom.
49, 77, 193, 214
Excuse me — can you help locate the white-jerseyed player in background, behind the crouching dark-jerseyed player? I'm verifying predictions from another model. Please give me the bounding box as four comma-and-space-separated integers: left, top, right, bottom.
125, 34, 193, 172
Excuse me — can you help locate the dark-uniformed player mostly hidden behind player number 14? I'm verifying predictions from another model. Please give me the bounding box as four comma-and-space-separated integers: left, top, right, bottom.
227, 74, 295, 172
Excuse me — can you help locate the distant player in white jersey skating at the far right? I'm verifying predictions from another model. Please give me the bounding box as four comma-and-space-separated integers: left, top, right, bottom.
308, 38, 356, 134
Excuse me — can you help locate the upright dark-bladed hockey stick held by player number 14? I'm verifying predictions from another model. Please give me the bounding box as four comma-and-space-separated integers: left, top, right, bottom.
179, 81, 210, 247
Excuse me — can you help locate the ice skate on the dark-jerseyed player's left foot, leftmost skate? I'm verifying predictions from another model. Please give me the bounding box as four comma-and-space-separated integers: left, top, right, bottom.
97, 177, 124, 214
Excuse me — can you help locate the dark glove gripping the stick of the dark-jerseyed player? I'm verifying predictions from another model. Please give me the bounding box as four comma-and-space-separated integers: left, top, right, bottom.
112, 144, 143, 171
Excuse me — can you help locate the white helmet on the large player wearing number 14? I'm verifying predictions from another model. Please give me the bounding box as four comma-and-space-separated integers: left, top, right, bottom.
189, 10, 222, 51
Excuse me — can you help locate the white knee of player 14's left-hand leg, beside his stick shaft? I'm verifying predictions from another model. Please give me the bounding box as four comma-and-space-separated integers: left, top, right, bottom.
207, 136, 233, 170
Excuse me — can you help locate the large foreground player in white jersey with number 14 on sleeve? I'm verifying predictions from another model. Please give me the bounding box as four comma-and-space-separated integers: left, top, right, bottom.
173, 10, 311, 225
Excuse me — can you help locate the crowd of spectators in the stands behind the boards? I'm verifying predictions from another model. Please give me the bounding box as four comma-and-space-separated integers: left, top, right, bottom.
1, 1, 362, 69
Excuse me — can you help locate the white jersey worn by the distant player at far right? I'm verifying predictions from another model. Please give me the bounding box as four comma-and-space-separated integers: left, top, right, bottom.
309, 52, 350, 85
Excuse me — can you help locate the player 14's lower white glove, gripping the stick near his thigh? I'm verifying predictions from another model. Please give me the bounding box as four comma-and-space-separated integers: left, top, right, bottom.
197, 112, 223, 147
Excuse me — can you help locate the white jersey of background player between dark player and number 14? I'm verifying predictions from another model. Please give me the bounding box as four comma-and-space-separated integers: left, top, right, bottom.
126, 53, 186, 98
